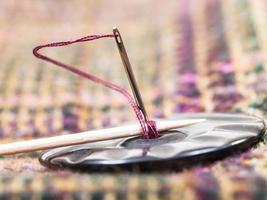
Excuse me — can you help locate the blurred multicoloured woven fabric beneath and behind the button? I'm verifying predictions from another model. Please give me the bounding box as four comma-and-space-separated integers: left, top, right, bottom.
0, 0, 267, 200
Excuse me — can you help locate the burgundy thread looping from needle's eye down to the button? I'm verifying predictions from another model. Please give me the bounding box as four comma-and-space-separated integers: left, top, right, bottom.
33, 34, 158, 139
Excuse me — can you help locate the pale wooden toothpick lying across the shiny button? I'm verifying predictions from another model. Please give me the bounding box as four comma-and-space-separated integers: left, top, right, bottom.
0, 119, 205, 155
